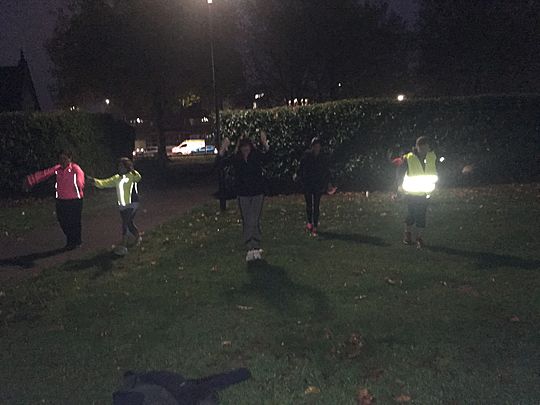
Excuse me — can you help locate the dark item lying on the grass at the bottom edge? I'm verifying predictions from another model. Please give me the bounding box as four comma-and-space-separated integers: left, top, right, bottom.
113, 368, 251, 405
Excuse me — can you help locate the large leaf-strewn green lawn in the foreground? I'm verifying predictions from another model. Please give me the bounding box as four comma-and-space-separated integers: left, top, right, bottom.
0, 186, 540, 404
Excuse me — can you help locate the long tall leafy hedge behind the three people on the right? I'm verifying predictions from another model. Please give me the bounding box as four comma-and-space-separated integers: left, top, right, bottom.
223, 95, 540, 189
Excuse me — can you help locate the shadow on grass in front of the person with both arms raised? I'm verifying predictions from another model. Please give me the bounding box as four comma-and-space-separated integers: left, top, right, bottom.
234, 260, 330, 318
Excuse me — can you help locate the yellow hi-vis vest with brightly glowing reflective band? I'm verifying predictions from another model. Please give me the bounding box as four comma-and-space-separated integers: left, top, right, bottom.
401, 152, 439, 196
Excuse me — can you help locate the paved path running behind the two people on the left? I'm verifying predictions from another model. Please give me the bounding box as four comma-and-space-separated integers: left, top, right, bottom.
0, 184, 217, 286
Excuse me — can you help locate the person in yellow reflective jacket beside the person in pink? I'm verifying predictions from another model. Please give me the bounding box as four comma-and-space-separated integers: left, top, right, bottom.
89, 158, 142, 254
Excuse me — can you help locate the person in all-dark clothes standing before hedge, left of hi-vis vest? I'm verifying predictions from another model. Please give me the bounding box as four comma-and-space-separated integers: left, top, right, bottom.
298, 138, 336, 236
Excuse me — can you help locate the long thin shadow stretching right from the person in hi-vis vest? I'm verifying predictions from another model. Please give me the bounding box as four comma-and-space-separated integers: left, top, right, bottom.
426, 246, 540, 270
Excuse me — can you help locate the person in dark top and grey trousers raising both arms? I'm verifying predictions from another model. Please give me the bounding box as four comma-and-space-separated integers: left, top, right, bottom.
218, 131, 270, 262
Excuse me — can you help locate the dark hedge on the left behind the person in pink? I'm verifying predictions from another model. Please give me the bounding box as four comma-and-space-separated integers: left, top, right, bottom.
0, 112, 135, 195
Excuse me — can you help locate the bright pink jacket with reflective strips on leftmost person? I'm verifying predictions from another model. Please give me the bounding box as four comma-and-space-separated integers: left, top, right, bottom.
26, 163, 84, 200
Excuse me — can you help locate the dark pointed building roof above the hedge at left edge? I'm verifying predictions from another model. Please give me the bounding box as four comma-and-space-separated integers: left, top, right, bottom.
0, 51, 41, 112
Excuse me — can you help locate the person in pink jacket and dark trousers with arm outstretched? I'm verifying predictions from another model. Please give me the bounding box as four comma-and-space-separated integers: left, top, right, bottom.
24, 151, 84, 250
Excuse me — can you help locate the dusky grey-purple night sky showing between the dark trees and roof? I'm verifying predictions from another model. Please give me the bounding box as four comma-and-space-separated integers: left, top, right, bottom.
0, 0, 416, 109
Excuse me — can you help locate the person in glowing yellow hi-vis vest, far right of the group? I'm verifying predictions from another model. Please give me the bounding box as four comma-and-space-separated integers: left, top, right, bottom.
392, 136, 439, 249
